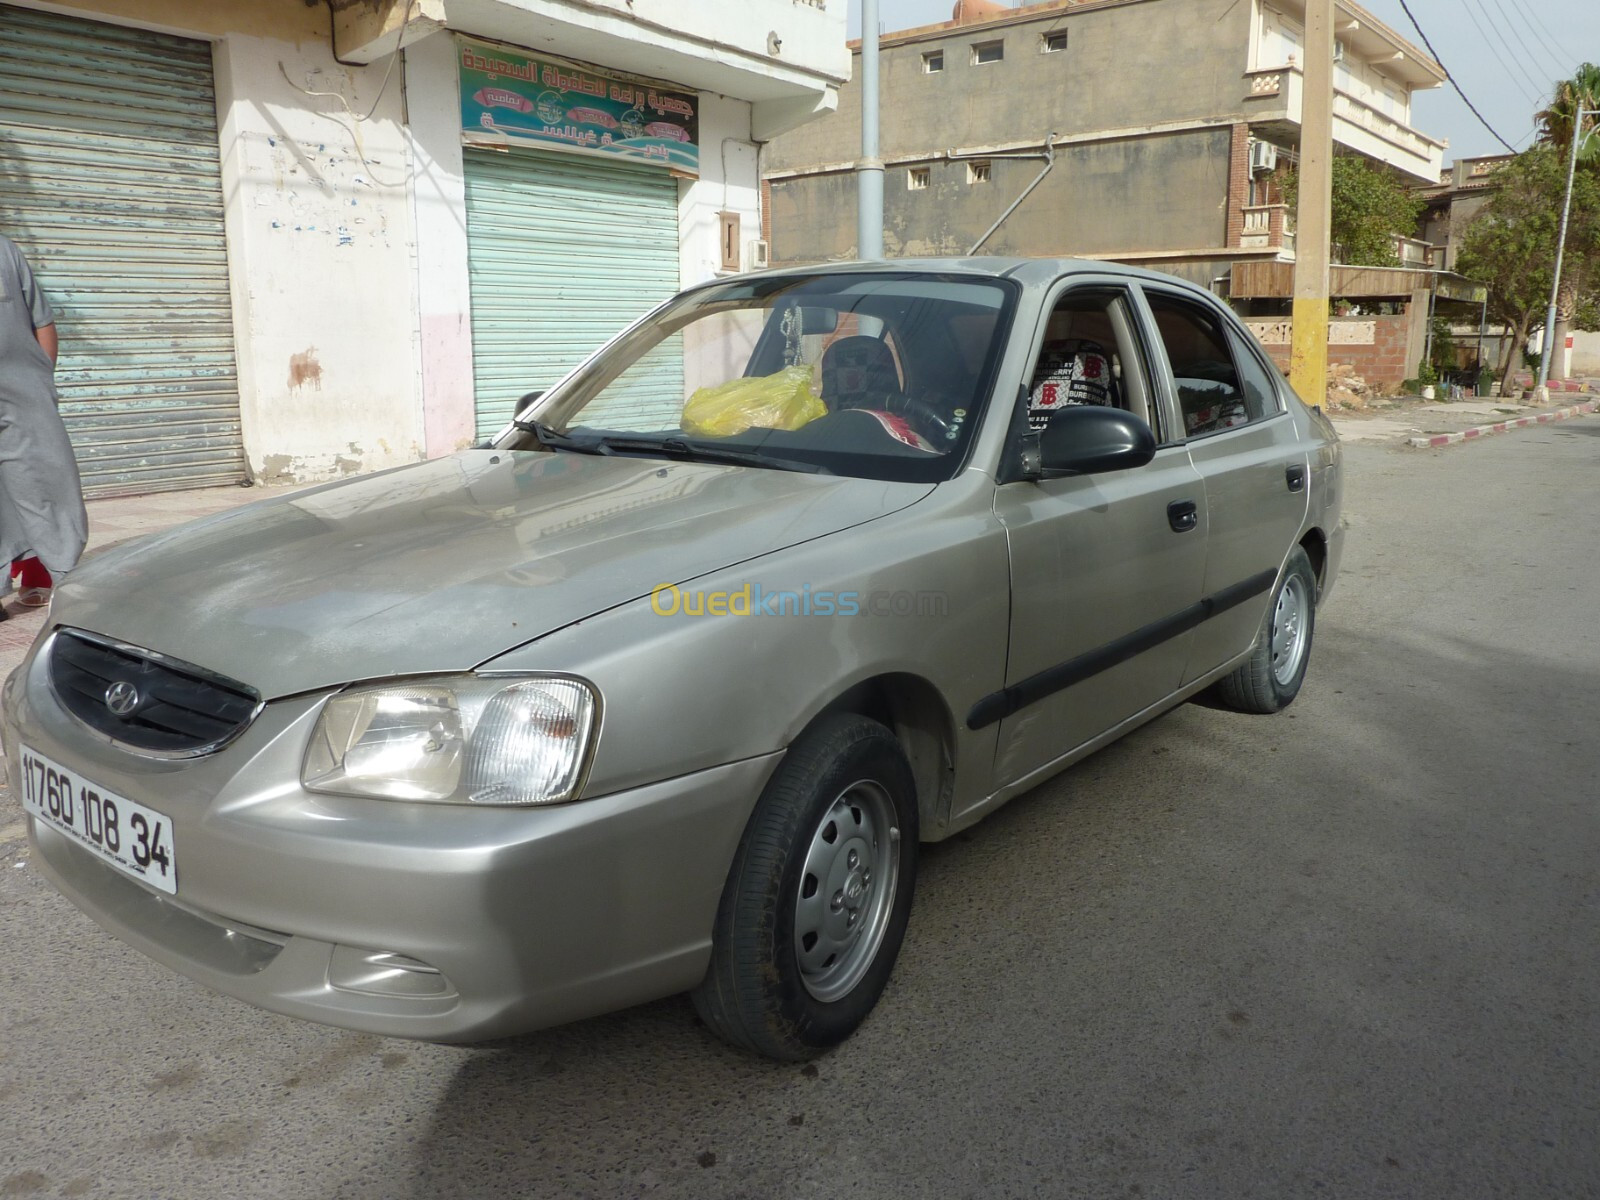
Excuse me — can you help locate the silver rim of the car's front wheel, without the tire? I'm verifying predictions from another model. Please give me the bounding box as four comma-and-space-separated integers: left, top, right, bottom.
794, 779, 901, 1003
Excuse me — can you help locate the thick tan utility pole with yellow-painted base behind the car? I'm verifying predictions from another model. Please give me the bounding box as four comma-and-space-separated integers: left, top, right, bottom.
1290, 0, 1334, 405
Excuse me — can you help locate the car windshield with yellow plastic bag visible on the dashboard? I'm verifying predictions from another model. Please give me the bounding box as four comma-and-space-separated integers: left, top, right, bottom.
498, 272, 1016, 482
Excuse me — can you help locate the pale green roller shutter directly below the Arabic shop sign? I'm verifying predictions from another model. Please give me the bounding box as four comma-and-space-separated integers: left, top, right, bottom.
466, 147, 678, 437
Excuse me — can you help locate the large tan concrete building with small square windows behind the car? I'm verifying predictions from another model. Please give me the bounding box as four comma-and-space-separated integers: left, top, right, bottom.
765, 0, 1445, 285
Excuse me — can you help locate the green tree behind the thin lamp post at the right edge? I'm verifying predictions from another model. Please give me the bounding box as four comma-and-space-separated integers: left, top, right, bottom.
1456, 148, 1600, 381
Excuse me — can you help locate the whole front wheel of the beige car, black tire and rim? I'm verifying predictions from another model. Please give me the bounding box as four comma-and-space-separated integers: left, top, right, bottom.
693, 714, 917, 1061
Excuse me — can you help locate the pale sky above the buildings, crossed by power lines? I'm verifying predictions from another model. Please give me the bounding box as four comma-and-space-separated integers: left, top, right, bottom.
848, 0, 1600, 163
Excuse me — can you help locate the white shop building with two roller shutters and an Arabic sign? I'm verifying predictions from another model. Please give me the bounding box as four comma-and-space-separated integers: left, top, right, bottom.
0, 0, 850, 494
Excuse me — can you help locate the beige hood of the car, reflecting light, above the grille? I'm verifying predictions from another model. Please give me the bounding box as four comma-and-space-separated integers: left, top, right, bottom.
53, 450, 931, 699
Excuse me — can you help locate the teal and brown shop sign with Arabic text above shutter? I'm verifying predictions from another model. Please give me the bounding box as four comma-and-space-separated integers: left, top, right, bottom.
458, 38, 699, 173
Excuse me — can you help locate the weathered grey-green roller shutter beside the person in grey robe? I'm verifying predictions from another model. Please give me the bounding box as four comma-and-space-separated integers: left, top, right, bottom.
0, 5, 245, 496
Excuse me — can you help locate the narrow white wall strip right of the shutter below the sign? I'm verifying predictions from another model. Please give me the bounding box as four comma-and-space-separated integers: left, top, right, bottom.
678, 91, 762, 288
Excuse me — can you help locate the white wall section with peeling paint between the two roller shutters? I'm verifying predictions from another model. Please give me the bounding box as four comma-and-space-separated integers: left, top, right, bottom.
214, 34, 424, 482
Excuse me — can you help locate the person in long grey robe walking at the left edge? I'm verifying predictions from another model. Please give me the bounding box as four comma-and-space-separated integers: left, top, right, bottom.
0, 234, 88, 611
